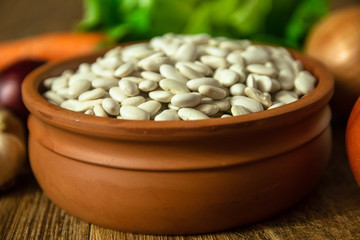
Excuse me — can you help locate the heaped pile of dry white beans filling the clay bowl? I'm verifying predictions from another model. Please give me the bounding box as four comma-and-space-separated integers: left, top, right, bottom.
43, 33, 316, 121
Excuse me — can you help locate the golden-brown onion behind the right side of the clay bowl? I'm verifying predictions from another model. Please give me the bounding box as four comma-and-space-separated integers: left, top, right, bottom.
305, 5, 360, 117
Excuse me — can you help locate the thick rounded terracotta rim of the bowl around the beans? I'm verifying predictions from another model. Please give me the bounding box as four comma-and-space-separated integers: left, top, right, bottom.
22, 43, 334, 132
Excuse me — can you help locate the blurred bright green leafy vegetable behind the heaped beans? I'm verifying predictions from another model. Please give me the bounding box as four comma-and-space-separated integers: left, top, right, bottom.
78, 0, 330, 48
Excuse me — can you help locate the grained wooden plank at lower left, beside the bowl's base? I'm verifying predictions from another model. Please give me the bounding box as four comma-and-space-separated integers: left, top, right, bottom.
0, 173, 90, 240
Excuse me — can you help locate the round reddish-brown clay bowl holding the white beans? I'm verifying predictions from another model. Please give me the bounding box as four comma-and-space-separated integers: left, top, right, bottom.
22, 43, 333, 234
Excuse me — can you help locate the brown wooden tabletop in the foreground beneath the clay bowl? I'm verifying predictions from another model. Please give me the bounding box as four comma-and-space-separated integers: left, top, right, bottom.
0, 119, 360, 240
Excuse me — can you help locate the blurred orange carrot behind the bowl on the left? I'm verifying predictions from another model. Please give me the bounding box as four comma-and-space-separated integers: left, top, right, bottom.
0, 32, 109, 71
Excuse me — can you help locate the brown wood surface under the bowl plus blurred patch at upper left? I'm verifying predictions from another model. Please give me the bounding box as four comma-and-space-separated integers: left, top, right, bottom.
0, 0, 360, 240
